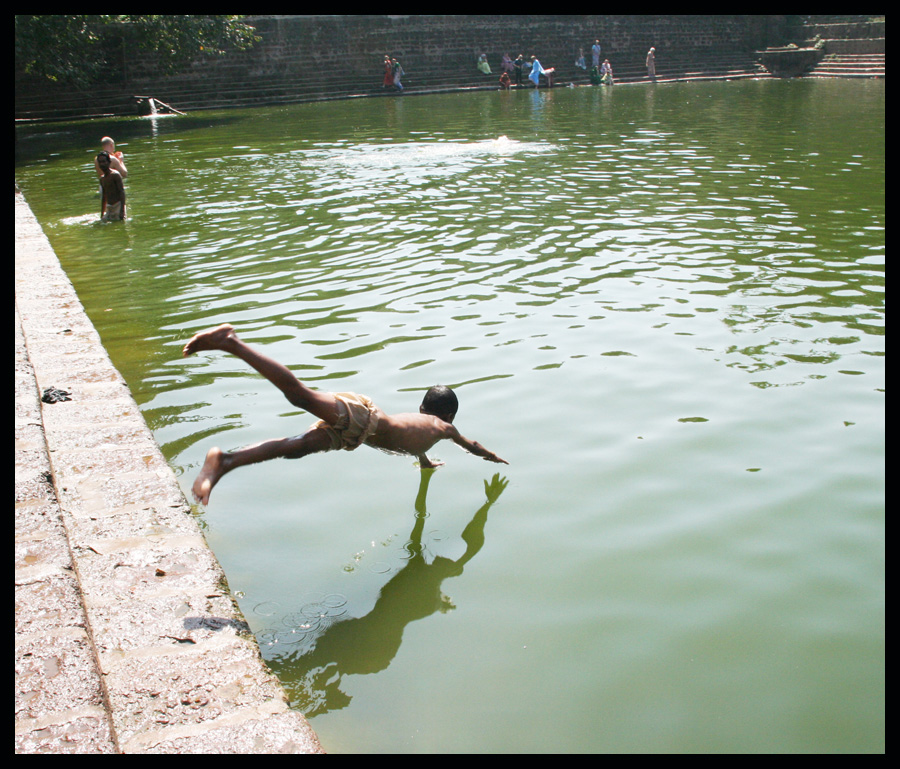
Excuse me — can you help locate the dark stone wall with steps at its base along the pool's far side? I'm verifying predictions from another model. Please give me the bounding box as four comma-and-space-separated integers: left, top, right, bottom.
15, 16, 788, 120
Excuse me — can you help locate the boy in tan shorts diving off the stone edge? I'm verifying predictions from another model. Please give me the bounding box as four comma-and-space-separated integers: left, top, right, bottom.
183, 323, 509, 504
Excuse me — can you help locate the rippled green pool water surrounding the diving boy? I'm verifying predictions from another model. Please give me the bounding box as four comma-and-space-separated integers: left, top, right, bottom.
16, 81, 885, 752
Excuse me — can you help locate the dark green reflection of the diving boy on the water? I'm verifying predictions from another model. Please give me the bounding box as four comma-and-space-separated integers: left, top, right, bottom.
268, 469, 509, 716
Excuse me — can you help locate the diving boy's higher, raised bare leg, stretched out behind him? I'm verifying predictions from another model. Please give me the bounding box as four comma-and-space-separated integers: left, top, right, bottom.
182, 323, 338, 425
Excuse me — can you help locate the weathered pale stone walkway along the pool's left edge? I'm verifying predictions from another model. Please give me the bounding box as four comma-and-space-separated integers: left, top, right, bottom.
15, 189, 322, 753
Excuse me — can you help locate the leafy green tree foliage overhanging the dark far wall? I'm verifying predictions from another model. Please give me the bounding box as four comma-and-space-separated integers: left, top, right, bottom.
16, 15, 260, 88
